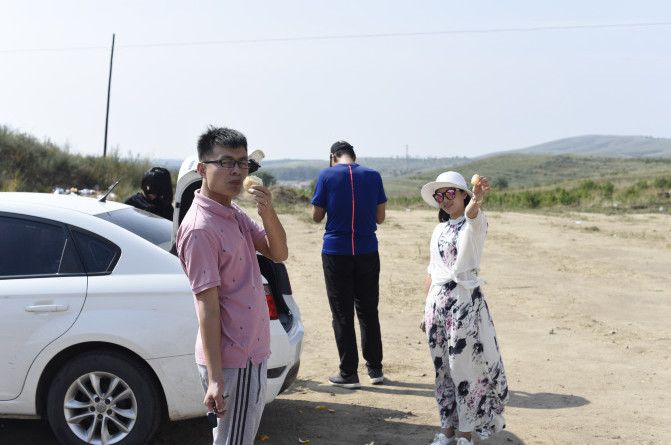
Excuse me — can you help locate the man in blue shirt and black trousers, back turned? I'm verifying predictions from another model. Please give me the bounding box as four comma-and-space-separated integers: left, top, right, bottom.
312, 141, 387, 388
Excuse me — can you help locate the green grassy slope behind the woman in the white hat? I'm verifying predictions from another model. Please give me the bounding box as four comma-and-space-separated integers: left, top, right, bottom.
385, 154, 671, 213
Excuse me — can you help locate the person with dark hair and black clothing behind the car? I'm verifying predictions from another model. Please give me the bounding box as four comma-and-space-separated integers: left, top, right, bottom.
124, 167, 174, 221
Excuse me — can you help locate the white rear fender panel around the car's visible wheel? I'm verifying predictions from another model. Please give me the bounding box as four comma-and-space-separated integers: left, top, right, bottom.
0, 275, 198, 415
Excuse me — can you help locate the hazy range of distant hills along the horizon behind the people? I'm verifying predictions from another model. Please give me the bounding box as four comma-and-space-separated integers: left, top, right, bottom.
154, 135, 671, 187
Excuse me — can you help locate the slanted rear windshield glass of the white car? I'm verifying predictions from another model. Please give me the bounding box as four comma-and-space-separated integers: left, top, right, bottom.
96, 207, 172, 252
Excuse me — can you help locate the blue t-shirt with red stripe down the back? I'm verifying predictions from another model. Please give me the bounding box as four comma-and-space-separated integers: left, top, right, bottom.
312, 164, 387, 255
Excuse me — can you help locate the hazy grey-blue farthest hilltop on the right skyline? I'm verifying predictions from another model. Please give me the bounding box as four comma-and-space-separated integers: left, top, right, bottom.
506, 135, 671, 158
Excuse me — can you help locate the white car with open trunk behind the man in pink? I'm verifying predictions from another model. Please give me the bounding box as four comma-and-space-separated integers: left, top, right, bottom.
0, 193, 303, 445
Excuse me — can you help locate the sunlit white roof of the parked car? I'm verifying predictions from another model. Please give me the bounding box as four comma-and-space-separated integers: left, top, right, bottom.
0, 192, 128, 215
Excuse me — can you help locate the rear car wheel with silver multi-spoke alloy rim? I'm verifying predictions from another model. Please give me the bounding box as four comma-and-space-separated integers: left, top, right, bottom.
46, 352, 161, 445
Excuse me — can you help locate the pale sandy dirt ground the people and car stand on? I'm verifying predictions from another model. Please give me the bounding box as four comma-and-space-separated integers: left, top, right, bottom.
0, 210, 671, 445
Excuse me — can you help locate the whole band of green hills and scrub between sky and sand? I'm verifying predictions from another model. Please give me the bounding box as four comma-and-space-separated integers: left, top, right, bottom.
5, 126, 671, 213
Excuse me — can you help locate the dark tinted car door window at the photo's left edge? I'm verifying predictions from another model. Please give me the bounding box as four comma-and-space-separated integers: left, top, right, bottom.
0, 216, 83, 277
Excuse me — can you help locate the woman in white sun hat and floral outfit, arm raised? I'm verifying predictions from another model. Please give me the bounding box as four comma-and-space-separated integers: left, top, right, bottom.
421, 171, 508, 445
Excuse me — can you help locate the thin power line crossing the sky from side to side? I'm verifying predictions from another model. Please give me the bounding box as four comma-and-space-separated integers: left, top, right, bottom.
0, 22, 671, 54
